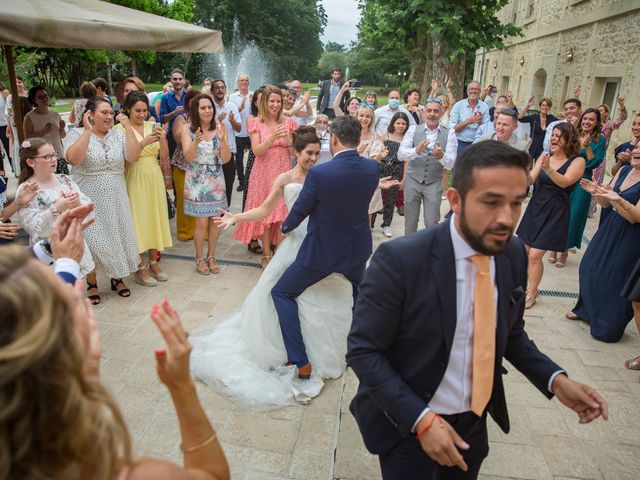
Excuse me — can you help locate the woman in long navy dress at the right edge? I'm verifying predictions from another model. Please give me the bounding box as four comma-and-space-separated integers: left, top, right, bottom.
566, 147, 640, 342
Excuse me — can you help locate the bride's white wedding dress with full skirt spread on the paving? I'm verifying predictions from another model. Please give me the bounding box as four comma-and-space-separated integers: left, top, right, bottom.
189, 183, 353, 407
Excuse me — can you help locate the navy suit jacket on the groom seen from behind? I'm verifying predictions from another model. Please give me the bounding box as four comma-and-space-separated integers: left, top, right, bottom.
282, 150, 380, 283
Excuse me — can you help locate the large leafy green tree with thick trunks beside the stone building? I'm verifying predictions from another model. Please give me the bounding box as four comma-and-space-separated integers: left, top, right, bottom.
358, 0, 521, 97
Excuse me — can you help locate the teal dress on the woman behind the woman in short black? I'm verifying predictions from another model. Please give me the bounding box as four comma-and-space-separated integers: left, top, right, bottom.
566, 135, 607, 249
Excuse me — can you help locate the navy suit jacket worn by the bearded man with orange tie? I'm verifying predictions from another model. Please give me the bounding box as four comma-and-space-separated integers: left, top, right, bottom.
347, 221, 561, 454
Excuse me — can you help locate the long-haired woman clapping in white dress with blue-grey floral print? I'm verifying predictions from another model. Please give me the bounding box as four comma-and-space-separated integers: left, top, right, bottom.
181, 93, 231, 275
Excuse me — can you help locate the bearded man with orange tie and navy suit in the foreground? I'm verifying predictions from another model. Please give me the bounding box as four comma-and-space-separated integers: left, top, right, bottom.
347, 141, 608, 480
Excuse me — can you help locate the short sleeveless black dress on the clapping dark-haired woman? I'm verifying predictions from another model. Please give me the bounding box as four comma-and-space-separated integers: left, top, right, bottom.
516, 156, 578, 252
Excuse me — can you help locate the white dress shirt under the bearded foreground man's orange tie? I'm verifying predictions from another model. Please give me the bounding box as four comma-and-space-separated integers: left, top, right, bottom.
412, 214, 564, 431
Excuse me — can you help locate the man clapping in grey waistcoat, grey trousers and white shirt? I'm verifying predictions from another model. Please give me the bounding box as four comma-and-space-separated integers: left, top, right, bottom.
398, 98, 458, 235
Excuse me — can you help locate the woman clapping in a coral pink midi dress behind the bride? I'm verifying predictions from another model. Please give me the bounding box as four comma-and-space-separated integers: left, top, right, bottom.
233, 86, 298, 267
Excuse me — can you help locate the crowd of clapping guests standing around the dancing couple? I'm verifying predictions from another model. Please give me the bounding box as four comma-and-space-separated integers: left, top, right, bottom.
0, 69, 640, 396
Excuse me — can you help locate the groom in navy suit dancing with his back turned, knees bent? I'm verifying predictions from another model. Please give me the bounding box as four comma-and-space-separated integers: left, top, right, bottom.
271, 115, 380, 379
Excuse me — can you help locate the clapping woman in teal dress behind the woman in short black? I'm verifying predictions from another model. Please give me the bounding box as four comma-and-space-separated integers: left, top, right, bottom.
549, 108, 607, 267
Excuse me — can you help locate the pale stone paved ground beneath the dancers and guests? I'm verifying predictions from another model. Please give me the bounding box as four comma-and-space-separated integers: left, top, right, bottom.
82, 185, 640, 480
